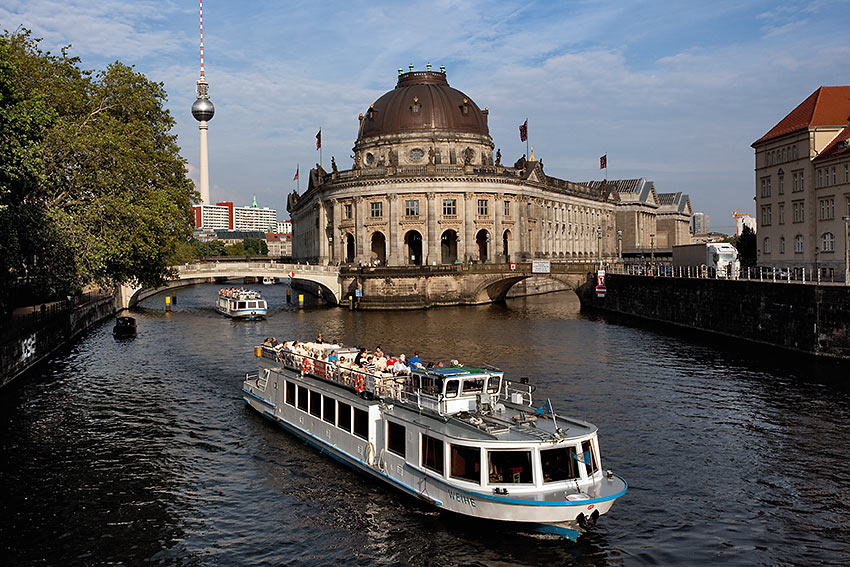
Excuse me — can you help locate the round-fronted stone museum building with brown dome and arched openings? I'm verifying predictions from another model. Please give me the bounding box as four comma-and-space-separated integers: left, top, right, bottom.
287, 66, 690, 266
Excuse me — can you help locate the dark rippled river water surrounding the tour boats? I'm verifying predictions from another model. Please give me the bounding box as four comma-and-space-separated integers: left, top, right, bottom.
0, 285, 850, 566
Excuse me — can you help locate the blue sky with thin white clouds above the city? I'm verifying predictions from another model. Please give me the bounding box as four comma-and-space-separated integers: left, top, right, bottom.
0, 0, 850, 233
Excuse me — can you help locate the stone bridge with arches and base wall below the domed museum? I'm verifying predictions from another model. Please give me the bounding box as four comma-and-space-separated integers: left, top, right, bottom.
120, 260, 596, 309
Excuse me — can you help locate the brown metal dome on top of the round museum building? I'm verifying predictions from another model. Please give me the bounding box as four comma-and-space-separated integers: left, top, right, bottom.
357, 69, 490, 143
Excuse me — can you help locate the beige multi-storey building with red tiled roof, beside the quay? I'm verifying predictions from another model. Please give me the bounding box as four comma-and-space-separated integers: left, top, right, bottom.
752, 86, 850, 279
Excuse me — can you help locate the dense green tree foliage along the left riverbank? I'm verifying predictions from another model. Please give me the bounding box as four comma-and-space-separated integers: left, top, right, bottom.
0, 30, 197, 316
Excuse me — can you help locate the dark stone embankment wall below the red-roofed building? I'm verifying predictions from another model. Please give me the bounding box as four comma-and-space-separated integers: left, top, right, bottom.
576, 274, 850, 359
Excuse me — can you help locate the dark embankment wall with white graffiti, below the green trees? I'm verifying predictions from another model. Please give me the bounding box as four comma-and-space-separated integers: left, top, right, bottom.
0, 297, 115, 387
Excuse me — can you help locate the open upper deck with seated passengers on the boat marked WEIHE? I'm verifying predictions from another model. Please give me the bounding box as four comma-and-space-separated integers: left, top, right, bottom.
255, 343, 596, 443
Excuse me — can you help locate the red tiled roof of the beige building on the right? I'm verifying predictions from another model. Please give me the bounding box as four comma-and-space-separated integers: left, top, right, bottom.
752, 86, 850, 146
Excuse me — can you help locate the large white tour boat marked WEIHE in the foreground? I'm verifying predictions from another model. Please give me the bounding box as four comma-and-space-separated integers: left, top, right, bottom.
242, 341, 627, 540
